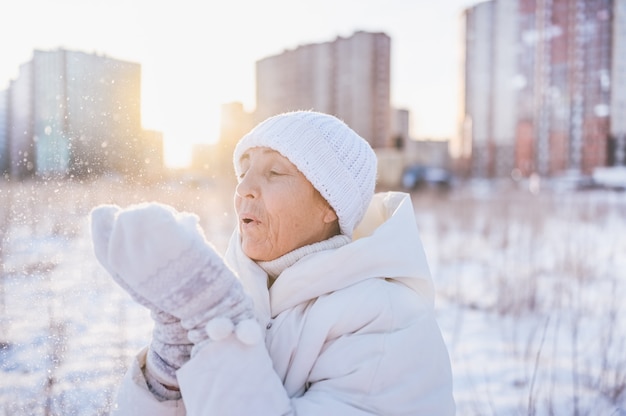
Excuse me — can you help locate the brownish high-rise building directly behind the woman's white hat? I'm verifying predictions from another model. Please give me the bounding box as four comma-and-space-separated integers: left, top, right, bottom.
255, 32, 393, 148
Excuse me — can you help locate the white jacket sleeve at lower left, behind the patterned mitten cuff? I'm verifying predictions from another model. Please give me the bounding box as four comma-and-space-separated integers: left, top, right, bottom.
110, 348, 186, 416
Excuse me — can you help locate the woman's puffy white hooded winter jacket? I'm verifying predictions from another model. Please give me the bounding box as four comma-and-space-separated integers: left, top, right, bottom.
115, 192, 455, 416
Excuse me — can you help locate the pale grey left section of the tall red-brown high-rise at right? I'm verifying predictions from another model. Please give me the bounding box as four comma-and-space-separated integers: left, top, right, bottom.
462, 0, 518, 176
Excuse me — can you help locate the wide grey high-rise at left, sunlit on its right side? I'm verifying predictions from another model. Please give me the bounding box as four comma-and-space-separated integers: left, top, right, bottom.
9, 49, 146, 177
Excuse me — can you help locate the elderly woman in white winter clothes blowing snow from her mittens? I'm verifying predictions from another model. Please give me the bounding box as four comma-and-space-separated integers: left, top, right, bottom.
91, 111, 455, 416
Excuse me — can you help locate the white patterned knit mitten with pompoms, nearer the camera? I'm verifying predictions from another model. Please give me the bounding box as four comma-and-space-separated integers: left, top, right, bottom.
92, 203, 261, 355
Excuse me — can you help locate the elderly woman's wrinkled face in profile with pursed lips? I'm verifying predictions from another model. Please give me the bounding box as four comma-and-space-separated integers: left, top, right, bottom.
235, 147, 339, 261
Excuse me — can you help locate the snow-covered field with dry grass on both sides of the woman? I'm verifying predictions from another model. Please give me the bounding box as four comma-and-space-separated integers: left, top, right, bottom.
0, 180, 626, 416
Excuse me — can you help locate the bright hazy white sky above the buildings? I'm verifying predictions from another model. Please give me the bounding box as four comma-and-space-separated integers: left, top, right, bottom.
0, 0, 479, 165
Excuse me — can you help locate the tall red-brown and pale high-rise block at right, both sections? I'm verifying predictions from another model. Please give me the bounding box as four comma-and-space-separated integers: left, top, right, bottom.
457, 0, 626, 176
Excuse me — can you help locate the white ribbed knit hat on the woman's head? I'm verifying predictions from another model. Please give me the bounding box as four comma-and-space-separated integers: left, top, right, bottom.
233, 111, 377, 236
